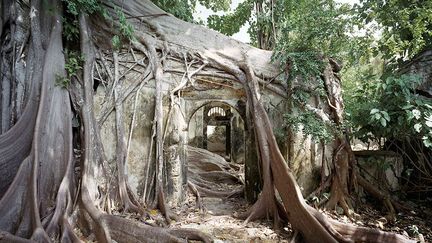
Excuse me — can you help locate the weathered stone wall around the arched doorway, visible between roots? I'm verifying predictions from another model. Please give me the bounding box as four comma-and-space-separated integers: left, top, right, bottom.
94, 52, 330, 205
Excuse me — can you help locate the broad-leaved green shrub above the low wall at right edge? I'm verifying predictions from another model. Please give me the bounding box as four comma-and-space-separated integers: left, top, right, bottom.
347, 75, 432, 147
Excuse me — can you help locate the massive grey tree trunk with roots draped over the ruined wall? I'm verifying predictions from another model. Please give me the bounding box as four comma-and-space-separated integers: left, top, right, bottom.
0, 0, 416, 242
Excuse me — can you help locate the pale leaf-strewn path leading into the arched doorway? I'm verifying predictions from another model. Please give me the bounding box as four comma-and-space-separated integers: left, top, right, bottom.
171, 147, 290, 242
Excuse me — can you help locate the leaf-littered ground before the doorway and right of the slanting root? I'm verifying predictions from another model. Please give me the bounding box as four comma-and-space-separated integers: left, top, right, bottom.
166, 194, 432, 242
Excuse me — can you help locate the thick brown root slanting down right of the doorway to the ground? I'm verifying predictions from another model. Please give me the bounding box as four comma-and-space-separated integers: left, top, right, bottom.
206, 54, 411, 242
